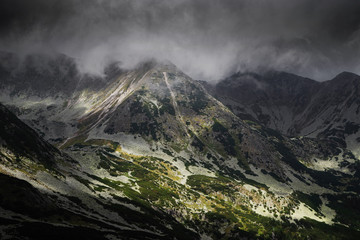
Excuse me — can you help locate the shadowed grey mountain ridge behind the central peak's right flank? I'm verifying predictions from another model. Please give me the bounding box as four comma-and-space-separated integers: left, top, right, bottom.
206, 72, 360, 157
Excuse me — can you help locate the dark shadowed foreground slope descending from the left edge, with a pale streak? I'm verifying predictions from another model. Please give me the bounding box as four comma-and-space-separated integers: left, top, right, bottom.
0, 102, 197, 239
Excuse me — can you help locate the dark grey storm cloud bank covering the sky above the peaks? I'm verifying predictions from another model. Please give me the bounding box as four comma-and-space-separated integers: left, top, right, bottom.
0, 0, 360, 80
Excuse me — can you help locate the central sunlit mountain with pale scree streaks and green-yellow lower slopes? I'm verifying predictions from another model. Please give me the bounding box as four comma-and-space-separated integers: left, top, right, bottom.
0, 52, 360, 239
